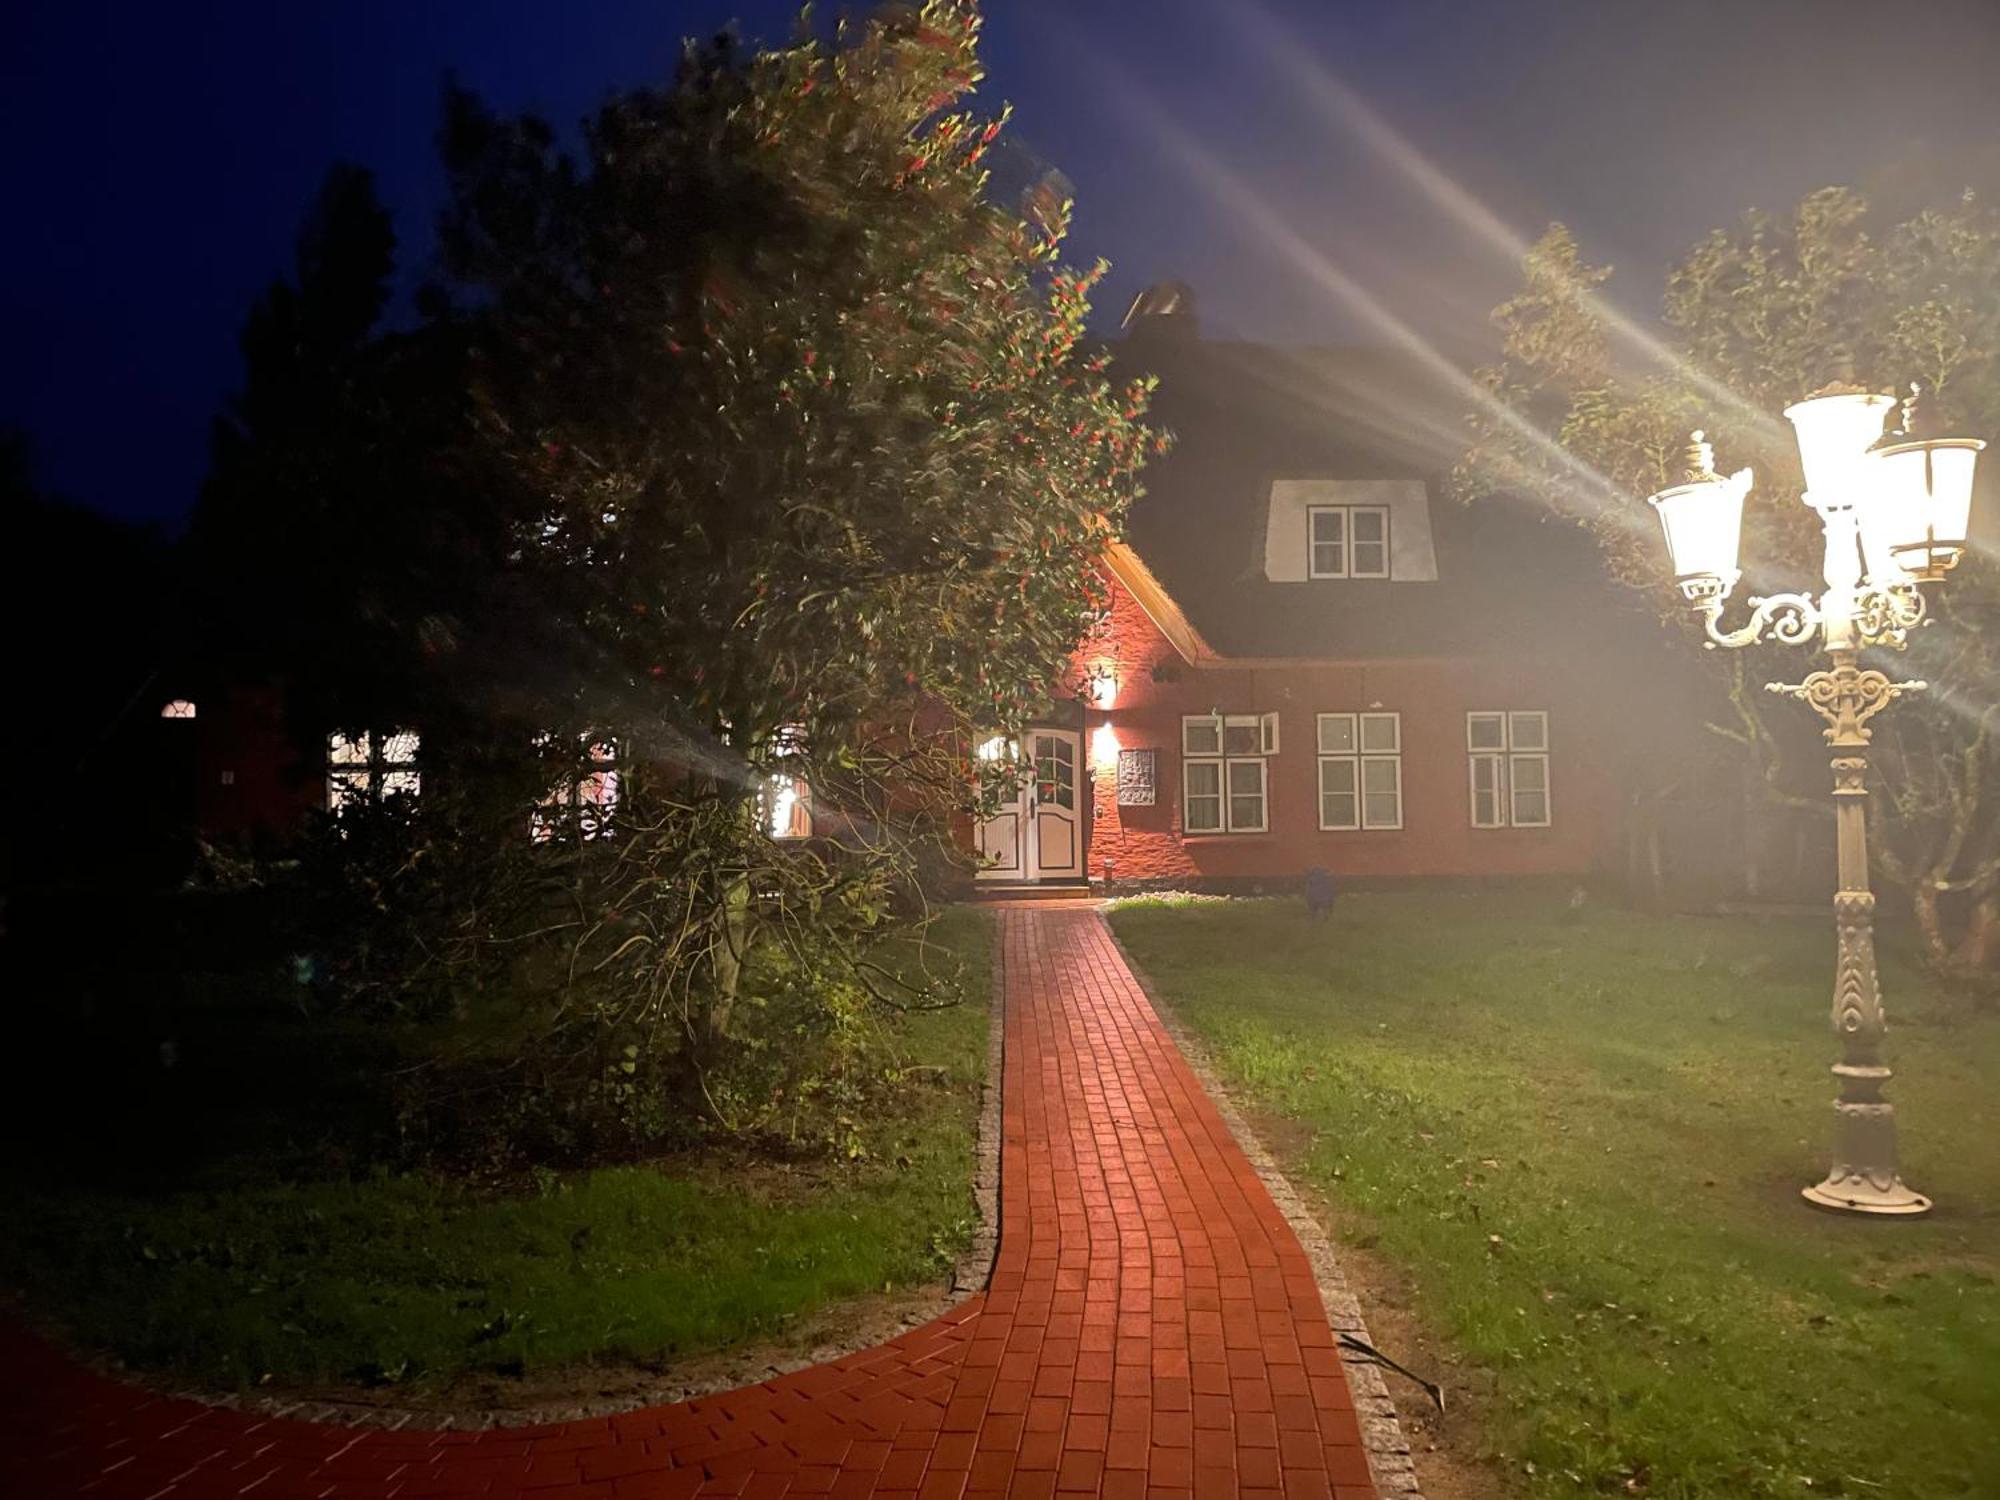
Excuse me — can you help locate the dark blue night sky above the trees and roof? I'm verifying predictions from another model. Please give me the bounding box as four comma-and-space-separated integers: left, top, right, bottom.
0, 0, 2000, 520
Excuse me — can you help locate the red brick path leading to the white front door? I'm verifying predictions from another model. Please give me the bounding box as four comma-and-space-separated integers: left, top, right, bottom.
0, 908, 1374, 1500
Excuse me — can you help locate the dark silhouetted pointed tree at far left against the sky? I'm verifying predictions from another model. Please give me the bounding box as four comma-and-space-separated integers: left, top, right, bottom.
188, 164, 496, 742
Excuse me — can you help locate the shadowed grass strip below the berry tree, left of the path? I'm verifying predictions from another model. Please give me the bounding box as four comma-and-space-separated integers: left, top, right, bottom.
0, 910, 990, 1394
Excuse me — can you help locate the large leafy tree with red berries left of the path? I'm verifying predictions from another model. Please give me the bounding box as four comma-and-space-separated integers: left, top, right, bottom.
302, 0, 1154, 1152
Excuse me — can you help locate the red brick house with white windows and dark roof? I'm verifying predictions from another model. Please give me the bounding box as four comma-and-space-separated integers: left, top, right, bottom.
976, 300, 1644, 888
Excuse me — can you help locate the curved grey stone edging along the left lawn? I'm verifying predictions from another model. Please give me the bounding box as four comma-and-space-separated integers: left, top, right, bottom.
117, 918, 1008, 1432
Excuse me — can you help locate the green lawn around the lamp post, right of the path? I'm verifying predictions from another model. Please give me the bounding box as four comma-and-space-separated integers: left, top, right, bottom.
1112, 894, 2000, 1500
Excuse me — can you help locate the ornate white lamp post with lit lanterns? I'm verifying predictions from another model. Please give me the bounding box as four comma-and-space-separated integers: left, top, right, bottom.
1650, 386, 1986, 1216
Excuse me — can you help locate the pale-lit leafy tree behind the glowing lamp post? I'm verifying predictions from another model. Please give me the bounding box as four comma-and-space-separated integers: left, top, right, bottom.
1460, 188, 2000, 968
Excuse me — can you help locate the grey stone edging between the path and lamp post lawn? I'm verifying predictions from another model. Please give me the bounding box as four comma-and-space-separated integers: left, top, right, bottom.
1098, 906, 1424, 1500
